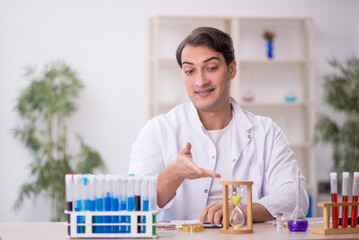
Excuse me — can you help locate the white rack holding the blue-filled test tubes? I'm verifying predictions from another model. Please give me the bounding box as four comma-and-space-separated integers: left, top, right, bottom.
65, 210, 158, 239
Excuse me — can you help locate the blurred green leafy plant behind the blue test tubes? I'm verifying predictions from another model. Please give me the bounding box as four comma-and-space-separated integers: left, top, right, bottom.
13, 61, 104, 221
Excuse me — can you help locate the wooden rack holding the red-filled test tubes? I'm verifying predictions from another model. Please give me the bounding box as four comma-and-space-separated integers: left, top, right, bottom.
312, 202, 359, 235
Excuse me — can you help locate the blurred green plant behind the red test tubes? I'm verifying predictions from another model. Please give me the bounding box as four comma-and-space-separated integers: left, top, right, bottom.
315, 56, 359, 172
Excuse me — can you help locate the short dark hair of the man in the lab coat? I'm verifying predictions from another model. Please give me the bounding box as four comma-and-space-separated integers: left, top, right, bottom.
176, 27, 235, 68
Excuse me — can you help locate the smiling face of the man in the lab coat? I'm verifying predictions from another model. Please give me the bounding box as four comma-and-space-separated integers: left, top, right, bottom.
181, 45, 237, 111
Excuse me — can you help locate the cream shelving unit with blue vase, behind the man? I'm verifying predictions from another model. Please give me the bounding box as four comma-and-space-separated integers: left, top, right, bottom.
149, 16, 317, 216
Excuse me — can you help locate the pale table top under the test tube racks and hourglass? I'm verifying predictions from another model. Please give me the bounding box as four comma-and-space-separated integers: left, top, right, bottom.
0, 218, 359, 240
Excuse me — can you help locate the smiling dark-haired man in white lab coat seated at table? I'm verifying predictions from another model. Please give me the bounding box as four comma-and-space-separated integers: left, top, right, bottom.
129, 27, 308, 223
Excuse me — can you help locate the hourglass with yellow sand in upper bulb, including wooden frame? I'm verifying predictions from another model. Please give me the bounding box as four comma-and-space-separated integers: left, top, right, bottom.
220, 181, 253, 233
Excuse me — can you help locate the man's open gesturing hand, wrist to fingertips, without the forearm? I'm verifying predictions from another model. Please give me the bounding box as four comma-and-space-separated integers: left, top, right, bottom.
173, 142, 221, 181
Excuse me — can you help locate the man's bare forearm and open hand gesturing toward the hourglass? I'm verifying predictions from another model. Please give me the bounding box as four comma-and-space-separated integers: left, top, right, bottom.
157, 142, 221, 208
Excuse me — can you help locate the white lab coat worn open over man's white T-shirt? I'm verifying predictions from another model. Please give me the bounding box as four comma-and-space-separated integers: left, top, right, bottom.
129, 99, 308, 220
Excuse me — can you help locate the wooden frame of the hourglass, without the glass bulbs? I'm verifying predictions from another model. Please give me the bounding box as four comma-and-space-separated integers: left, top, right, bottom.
219, 181, 253, 234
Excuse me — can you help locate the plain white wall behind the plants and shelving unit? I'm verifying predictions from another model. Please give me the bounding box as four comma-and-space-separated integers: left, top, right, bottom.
0, 0, 359, 221
